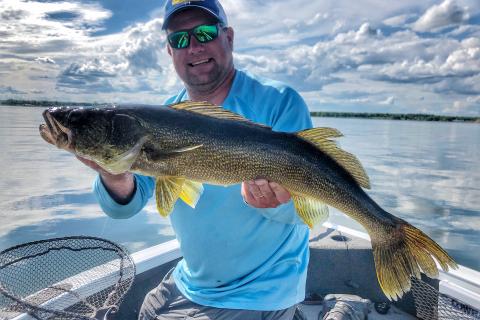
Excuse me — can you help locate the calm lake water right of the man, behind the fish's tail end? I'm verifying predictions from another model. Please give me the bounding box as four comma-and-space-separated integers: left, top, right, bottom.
314, 118, 480, 270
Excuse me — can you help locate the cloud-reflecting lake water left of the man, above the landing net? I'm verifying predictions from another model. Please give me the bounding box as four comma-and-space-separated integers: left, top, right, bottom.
0, 107, 174, 252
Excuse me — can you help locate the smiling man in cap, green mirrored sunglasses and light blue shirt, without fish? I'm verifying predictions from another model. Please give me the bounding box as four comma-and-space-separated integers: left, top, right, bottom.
81, 0, 312, 320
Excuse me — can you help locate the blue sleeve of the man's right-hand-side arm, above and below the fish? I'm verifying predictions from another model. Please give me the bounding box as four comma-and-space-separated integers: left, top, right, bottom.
257, 87, 313, 224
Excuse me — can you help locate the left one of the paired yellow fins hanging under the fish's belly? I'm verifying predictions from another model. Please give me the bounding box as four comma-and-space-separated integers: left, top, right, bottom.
155, 177, 185, 217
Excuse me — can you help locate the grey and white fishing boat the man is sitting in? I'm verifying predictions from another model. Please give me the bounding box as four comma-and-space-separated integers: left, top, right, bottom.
0, 222, 480, 320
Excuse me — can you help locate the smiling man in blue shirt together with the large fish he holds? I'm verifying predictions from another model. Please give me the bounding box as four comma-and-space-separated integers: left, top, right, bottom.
39, 0, 457, 319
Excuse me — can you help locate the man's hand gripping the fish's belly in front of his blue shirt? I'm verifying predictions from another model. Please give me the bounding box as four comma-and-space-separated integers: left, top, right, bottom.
242, 179, 291, 208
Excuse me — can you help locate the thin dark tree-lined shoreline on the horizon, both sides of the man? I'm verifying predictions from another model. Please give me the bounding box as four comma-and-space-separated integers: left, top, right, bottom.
0, 99, 480, 123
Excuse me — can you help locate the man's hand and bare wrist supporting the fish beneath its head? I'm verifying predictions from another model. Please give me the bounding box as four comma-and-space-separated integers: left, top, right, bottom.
76, 156, 135, 204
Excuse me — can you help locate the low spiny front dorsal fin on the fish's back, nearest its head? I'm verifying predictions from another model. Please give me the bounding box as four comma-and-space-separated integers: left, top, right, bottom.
170, 101, 269, 128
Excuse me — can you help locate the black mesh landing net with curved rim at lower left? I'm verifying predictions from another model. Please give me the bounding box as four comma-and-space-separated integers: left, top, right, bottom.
0, 236, 135, 320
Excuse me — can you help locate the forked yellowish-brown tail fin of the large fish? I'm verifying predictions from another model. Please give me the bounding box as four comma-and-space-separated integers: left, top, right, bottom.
370, 220, 457, 300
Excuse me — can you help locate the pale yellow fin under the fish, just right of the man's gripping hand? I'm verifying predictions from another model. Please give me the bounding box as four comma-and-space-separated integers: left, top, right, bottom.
292, 194, 328, 228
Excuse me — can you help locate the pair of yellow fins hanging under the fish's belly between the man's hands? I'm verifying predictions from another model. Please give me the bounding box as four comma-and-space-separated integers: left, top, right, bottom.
155, 177, 203, 217
